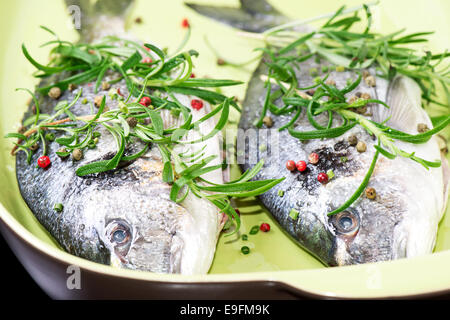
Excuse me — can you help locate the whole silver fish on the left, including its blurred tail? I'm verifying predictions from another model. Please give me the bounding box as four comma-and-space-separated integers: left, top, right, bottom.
16, 1, 224, 274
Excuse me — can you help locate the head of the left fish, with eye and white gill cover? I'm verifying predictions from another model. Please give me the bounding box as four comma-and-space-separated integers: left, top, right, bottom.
85, 159, 220, 274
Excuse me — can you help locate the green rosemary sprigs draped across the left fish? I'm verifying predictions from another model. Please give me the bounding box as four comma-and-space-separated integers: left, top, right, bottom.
6, 28, 283, 232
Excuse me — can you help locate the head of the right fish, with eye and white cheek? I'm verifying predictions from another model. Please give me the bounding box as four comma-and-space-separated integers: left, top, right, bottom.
327, 151, 442, 265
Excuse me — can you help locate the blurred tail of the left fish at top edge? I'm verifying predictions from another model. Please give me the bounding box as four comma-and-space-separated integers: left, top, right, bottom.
65, 0, 136, 42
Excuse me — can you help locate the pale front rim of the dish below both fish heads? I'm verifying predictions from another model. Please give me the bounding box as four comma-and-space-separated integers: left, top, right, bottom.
0, 203, 450, 299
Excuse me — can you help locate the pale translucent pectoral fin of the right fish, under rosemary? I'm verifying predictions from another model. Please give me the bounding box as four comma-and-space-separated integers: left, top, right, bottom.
373, 76, 433, 134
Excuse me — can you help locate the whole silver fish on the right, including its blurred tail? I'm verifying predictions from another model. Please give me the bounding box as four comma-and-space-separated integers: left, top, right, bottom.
189, 0, 449, 266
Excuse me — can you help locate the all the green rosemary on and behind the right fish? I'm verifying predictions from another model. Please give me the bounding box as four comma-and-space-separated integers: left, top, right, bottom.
236, 5, 450, 216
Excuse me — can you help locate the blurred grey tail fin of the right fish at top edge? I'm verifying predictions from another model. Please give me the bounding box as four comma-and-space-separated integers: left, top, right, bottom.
185, 0, 289, 32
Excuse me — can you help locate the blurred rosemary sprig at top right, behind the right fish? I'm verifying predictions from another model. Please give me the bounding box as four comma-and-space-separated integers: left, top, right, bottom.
241, 4, 450, 107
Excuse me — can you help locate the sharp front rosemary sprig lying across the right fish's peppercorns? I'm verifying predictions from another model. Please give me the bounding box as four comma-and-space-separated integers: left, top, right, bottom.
282, 76, 450, 215
